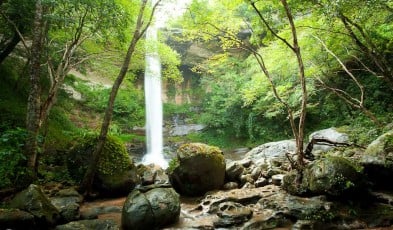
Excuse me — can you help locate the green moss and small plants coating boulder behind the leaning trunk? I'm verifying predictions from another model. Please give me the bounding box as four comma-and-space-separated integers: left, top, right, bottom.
67, 134, 133, 182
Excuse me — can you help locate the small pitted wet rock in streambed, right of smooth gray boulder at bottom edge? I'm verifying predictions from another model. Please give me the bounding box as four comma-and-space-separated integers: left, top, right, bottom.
214, 201, 252, 227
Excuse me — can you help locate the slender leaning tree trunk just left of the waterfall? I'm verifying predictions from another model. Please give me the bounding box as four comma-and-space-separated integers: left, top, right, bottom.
80, 0, 160, 195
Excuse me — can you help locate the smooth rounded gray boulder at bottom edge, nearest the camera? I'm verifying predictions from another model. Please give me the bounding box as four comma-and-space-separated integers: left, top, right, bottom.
121, 188, 180, 230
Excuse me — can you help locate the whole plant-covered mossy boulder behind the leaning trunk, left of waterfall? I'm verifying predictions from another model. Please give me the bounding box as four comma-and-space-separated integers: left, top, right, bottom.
67, 135, 140, 195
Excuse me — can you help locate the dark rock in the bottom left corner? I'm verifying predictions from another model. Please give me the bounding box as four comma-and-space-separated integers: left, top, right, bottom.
0, 209, 36, 230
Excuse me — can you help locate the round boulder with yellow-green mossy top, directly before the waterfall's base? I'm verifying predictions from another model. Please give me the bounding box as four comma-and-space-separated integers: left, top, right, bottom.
168, 143, 225, 196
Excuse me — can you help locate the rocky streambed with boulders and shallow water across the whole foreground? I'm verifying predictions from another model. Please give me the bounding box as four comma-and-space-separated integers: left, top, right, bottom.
0, 126, 393, 229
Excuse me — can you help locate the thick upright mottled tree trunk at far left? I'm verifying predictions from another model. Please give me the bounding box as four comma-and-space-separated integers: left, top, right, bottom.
25, 0, 43, 177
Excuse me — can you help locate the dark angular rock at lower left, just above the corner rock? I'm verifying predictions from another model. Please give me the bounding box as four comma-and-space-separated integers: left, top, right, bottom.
10, 184, 60, 227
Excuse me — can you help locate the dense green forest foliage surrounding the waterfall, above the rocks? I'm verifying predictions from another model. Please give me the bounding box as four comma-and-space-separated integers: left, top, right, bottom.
0, 0, 393, 188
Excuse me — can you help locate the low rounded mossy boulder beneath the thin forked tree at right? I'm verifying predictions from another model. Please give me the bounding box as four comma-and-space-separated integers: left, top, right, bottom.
283, 156, 364, 197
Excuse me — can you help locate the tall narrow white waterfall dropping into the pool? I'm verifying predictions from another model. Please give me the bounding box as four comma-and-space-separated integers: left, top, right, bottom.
142, 1, 168, 169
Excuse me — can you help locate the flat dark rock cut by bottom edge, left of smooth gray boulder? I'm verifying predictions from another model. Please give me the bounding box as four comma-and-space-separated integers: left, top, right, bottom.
55, 219, 120, 230
